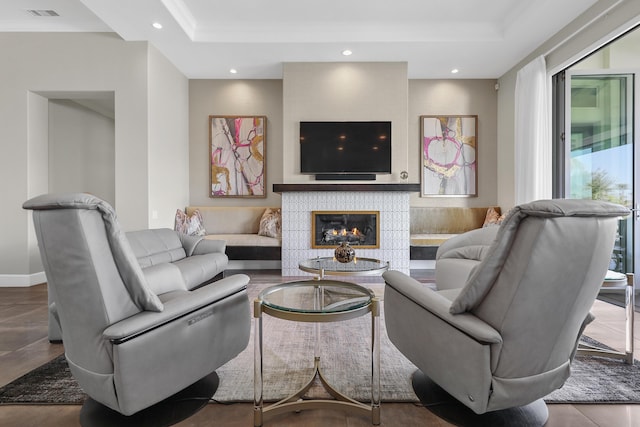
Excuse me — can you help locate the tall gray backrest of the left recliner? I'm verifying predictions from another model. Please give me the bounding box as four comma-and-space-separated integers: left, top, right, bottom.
23, 193, 163, 374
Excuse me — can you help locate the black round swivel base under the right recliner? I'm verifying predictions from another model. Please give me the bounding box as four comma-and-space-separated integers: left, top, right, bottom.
411, 369, 549, 427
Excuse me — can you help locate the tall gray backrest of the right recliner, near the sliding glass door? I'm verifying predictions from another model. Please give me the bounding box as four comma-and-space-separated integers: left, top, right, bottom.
451, 200, 629, 378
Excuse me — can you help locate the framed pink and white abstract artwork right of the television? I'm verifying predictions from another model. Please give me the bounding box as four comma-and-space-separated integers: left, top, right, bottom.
420, 116, 478, 197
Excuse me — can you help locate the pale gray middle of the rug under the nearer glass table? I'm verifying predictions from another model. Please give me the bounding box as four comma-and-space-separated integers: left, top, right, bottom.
213, 283, 418, 402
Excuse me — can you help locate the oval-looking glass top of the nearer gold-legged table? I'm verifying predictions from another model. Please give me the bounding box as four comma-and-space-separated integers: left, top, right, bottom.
258, 280, 374, 313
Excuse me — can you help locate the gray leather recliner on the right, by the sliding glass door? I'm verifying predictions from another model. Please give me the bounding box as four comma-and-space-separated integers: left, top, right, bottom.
383, 200, 629, 422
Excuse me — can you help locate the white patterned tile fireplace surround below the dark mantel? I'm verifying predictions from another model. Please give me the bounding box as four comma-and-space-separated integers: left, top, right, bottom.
274, 184, 420, 276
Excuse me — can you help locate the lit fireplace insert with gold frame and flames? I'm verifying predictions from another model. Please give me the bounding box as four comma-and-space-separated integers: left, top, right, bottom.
311, 211, 380, 249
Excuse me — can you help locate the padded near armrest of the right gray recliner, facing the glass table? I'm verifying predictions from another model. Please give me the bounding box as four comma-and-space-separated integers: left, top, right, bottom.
383, 271, 502, 344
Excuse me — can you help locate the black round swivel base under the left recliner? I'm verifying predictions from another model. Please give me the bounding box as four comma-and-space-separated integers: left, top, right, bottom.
80, 372, 220, 427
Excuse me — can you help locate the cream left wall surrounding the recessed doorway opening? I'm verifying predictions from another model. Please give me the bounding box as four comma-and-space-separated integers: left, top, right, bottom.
0, 33, 188, 284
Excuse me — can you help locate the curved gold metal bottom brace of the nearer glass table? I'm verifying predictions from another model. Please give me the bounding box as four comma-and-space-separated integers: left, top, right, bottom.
254, 357, 380, 426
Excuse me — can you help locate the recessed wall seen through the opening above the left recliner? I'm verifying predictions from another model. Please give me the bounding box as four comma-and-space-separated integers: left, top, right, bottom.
48, 99, 115, 205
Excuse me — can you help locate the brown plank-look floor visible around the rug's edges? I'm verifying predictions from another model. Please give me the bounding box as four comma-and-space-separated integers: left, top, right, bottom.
0, 271, 640, 427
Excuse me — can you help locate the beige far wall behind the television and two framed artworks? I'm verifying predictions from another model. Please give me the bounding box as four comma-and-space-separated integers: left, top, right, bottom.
189, 68, 498, 206
